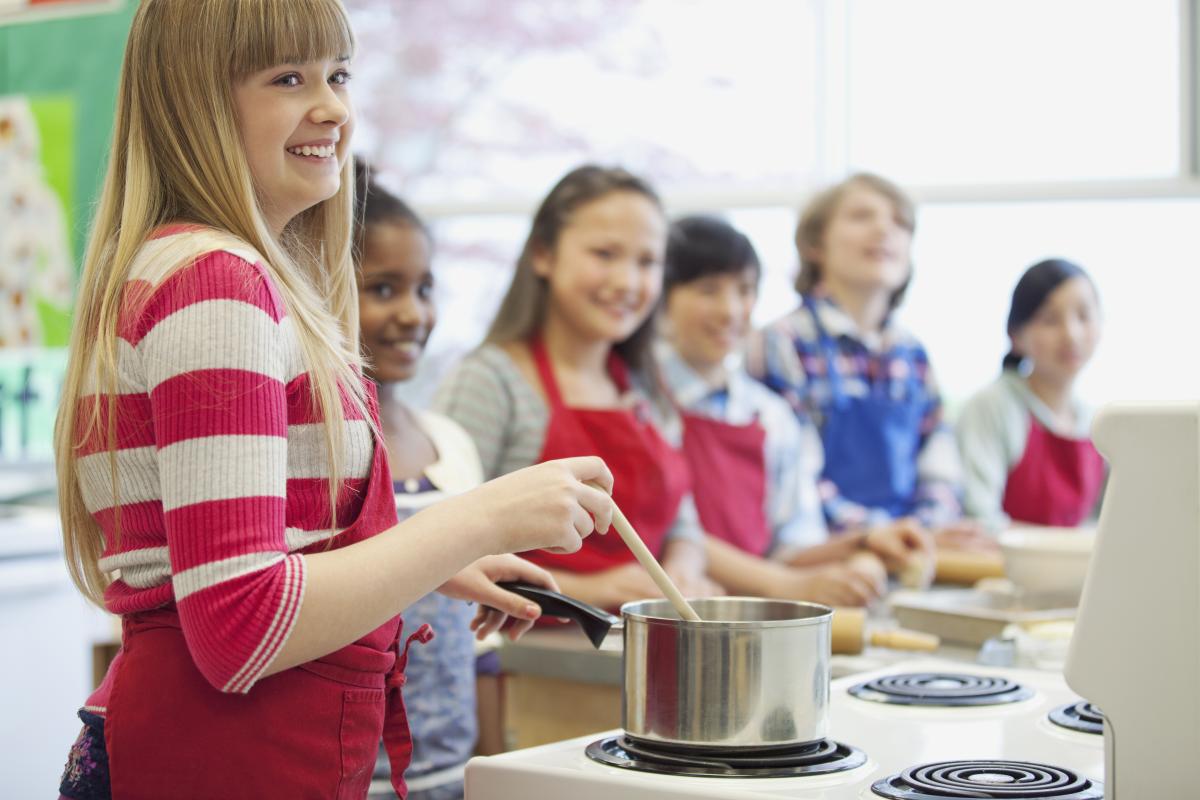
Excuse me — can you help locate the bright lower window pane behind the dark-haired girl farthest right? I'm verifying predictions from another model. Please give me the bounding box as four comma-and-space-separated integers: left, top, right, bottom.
904, 199, 1200, 407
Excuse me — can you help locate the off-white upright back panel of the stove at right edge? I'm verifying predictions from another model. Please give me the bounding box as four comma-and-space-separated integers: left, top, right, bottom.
1066, 403, 1200, 800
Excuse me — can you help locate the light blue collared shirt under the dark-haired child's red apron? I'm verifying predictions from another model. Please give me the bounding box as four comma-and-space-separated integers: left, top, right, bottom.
655, 342, 827, 558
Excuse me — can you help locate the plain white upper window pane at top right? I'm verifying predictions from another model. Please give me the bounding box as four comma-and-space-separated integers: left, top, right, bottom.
847, 0, 1181, 185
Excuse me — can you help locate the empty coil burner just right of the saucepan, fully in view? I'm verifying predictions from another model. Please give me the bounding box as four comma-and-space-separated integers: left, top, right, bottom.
850, 673, 1033, 706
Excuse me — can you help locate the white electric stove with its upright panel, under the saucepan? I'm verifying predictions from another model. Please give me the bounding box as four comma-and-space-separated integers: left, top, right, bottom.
467, 403, 1200, 800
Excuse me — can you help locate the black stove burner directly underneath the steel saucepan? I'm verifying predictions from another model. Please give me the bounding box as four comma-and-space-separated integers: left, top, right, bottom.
586, 735, 866, 777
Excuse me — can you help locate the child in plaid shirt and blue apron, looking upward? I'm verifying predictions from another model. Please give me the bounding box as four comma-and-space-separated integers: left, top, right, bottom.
748, 174, 977, 567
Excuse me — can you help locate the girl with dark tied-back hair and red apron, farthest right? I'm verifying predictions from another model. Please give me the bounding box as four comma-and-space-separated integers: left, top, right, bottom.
958, 259, 1104, 530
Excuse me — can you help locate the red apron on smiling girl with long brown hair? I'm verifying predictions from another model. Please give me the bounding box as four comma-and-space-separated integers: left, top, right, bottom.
524, 337, 689, 572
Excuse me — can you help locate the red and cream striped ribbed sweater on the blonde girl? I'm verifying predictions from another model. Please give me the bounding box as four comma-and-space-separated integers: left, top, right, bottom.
78, 228, 373, 695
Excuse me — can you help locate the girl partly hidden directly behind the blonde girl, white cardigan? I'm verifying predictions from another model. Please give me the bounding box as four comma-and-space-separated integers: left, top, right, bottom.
354, 161, 484, 800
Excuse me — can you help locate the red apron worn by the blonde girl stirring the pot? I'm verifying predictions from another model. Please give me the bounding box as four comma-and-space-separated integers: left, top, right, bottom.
104, 402, 432, 800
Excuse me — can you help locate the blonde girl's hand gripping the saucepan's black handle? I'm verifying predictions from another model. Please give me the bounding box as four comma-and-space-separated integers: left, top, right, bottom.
438, 555, 559, 640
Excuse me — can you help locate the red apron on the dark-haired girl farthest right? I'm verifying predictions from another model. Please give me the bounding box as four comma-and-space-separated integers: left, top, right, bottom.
1003, 414, 1104, 527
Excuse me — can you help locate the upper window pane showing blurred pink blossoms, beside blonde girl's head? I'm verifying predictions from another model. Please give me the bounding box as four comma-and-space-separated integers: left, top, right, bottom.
350, 0, 820, 205
